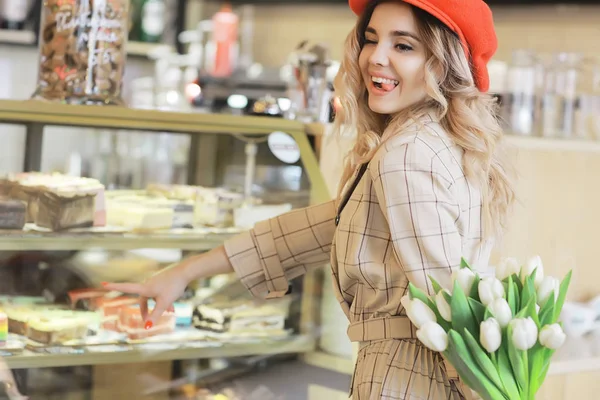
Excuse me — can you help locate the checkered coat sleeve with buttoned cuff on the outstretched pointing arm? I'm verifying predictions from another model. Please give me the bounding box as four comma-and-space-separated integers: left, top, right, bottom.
225, 200, 336, 298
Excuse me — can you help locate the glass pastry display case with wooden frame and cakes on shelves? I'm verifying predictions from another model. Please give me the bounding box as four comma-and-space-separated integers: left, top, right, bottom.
0, 97, 329, 399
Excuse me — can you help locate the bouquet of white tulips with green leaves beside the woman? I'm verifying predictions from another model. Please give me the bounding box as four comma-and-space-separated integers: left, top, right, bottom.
402, 257, 571, 400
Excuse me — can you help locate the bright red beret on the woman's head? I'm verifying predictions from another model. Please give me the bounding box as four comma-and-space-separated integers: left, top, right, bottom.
348, 0, 498, 92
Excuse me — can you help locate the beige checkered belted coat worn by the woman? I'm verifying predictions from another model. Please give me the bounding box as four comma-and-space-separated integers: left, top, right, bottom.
225, 117, 491, 400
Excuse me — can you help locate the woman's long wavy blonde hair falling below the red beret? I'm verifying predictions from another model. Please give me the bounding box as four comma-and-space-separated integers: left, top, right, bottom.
334, 0, 515, 237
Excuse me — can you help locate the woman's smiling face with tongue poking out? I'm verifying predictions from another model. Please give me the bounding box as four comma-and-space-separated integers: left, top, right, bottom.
358, 1, 426, 115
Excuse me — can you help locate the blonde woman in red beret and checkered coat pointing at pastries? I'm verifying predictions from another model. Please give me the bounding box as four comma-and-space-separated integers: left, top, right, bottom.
107, 0, 514, 400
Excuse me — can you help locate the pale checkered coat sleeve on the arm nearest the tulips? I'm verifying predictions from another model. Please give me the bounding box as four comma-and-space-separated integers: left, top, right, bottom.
370, 142, 462, 294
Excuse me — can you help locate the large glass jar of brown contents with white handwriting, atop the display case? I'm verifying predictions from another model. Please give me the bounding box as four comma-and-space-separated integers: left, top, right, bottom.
33, 0, 129, 105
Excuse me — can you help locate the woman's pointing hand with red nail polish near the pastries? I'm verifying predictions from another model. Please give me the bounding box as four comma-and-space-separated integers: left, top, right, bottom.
103, 265, 189, 329
